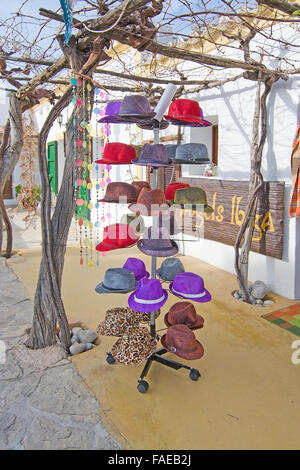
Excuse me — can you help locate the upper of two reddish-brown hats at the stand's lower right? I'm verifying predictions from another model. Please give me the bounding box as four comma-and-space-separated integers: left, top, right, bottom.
164, 302, 204, 330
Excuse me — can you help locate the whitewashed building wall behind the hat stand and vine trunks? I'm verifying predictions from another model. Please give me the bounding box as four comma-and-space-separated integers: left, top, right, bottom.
5, 21, 300, 299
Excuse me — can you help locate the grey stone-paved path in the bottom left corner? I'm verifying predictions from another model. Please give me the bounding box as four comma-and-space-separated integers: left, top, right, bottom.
0, 258, 120, 450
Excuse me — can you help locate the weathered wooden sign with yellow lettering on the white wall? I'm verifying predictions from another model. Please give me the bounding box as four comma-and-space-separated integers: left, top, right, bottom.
180, 178, 284, 259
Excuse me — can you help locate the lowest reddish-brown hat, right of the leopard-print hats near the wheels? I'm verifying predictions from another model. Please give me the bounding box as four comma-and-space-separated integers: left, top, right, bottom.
161, 325, 204, 360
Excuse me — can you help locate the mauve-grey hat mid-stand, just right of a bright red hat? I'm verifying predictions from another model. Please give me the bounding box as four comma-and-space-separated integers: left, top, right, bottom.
138, 226, 178, 258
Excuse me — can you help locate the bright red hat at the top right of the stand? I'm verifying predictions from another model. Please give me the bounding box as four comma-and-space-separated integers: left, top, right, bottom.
165, 99, 212, 127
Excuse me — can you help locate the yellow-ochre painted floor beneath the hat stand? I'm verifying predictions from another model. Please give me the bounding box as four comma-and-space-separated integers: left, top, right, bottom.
9, 248, 300, 450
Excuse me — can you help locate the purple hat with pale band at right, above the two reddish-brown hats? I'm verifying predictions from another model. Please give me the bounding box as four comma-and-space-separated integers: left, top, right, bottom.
170, 273, 211, 302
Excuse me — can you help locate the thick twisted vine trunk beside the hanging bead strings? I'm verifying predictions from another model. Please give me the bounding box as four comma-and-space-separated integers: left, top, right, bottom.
27, 35, 102, 349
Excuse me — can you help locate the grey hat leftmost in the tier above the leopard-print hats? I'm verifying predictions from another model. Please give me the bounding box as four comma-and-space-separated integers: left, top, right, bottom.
95, 268, 137, 294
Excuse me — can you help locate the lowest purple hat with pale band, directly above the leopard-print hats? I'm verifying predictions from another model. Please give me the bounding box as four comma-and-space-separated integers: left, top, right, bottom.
128, 278, 168, 312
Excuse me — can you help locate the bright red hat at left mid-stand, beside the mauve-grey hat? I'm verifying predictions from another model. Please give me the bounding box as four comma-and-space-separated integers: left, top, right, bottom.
96, 224, 140, 251
